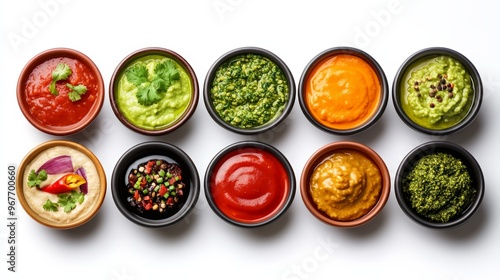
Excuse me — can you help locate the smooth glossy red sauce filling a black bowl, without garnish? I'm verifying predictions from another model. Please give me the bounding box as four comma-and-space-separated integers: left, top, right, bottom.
211, 148, 290, 223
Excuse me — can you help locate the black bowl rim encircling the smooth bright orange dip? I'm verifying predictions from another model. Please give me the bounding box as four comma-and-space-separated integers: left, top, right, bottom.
298, 46, 389, 135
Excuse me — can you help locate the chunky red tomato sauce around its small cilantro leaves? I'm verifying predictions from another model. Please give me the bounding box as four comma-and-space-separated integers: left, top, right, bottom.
25, 57, 99, 126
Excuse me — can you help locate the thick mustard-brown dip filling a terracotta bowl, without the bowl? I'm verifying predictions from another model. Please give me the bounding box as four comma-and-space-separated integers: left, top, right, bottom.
309, 150, 382, 221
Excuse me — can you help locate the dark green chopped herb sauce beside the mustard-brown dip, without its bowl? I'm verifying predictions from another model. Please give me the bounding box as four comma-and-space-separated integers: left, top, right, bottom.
403, 152, 476, 223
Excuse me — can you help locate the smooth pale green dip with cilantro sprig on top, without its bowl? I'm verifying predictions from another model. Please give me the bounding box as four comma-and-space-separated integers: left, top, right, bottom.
116, 55, 192, 130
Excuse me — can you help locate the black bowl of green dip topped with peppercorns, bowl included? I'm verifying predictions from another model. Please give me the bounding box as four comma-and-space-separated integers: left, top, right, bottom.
392, 47, 483, 135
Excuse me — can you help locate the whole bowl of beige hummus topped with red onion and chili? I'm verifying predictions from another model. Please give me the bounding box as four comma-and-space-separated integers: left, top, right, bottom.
16, 140, 106, 229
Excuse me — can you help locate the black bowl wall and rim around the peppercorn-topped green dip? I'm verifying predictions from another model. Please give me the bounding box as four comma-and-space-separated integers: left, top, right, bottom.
392, 47, 483, 135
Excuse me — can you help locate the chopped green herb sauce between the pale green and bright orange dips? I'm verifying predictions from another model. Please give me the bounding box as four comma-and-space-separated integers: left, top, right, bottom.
210, 54, 289, 128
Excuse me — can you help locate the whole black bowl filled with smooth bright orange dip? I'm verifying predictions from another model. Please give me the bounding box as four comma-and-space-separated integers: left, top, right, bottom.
298, 47, 389, 135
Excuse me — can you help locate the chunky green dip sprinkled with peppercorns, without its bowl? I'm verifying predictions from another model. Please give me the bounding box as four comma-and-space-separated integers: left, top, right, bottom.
401, 56, 474, 130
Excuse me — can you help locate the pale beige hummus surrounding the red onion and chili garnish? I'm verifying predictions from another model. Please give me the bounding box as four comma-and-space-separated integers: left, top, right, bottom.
22, 146, 101, 223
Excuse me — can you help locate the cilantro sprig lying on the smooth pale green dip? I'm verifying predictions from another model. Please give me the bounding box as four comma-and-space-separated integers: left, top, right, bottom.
125, 60, 180, 106
